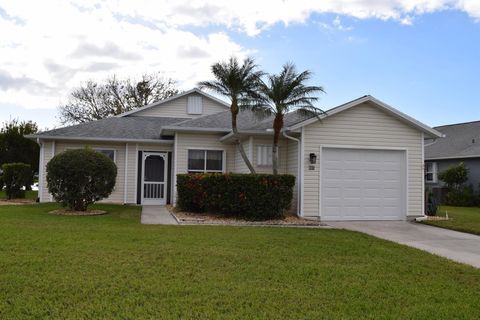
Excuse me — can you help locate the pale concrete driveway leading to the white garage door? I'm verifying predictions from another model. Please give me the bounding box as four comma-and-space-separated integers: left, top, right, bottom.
327, 221, 480, 268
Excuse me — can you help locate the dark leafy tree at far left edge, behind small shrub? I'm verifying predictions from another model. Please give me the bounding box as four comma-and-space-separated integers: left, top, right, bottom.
0, 119, 40, 184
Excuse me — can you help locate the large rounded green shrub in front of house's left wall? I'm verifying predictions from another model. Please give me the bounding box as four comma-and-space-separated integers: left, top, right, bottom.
47, 149, 117, 211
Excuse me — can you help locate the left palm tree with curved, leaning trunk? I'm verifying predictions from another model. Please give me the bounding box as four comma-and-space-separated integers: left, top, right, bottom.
198, 57, 264, 173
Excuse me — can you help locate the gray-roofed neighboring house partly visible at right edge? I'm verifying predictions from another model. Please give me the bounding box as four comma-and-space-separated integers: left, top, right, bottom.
425, 121, 480, 190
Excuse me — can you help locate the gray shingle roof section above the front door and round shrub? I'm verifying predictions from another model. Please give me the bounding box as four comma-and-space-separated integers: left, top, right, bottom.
36, 117, 187, 140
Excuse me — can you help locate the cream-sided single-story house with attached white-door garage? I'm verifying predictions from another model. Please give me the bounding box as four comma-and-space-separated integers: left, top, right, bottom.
31, 89, 441, 220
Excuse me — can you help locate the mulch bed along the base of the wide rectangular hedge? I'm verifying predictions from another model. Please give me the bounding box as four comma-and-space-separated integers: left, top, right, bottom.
167, 206, 326, 227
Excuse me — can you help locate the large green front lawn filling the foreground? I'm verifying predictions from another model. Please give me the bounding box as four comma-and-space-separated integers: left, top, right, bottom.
0, 204, 480, 319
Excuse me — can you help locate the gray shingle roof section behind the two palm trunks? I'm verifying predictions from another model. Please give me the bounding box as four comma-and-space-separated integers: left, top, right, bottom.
168, 110, 310, 132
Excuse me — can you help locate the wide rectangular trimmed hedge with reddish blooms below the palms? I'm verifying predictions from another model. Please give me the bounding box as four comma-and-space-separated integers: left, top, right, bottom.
177, 173, 295, 220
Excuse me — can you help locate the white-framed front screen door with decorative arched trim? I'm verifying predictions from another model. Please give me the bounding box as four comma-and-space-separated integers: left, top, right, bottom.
142, 152, 168, 205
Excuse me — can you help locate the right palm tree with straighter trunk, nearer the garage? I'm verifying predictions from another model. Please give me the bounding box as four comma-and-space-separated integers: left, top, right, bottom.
256, 63, 325, 174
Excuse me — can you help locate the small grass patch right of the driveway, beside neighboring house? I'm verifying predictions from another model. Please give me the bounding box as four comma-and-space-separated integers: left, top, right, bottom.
423, 206, 480, 235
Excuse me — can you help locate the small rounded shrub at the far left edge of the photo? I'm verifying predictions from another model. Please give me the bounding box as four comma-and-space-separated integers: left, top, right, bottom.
2, 163, 32, 199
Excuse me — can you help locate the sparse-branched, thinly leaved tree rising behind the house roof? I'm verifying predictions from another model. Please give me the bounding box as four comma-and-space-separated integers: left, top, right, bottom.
60, 73, 178, 124
